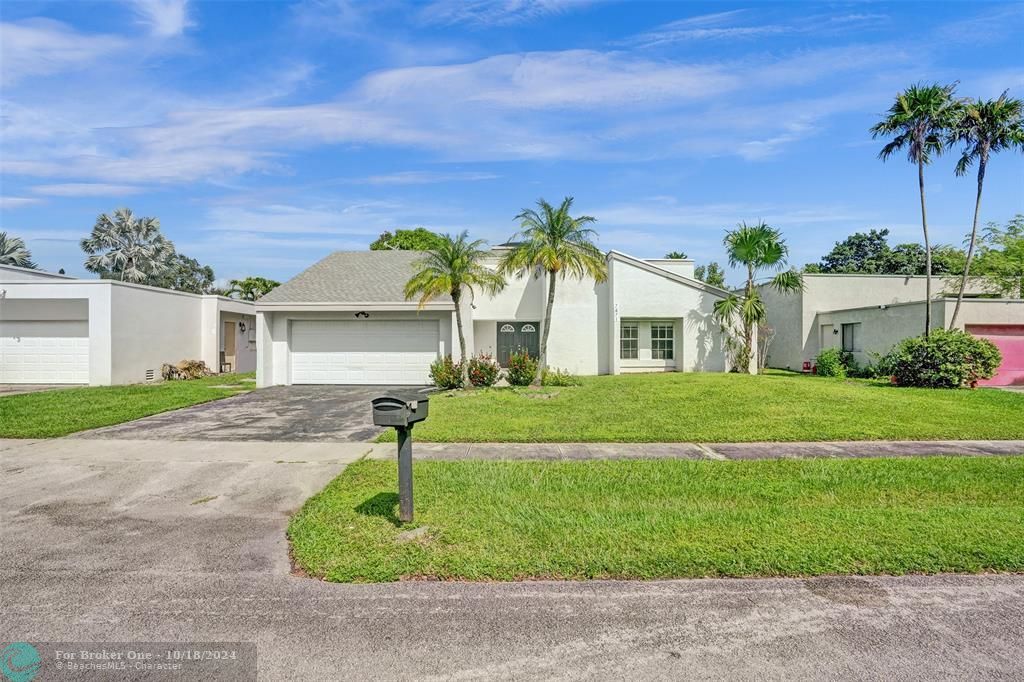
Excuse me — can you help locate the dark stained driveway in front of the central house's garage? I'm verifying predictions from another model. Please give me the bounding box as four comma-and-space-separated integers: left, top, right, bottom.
75, 386, 426, 442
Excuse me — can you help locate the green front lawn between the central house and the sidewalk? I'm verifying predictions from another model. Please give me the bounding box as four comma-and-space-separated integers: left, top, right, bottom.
381, 371, 1024, 442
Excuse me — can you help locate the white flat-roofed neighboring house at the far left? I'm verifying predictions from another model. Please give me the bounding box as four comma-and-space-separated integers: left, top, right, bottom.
0, 265, 256, 385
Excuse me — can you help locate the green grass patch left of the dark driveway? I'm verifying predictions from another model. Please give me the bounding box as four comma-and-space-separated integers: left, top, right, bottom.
0, 374, 255, 438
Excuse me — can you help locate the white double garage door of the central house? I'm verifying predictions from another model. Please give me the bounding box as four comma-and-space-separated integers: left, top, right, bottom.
292, 319, 439, 385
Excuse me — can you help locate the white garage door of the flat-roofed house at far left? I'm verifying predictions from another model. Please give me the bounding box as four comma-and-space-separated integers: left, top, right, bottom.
0, 321, 89, 384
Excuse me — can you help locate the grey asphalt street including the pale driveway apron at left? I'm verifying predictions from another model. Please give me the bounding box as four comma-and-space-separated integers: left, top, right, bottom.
0, 439, 1024, 680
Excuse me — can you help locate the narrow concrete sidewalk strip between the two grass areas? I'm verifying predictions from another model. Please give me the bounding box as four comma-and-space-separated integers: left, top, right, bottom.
371, 438, 1024, 460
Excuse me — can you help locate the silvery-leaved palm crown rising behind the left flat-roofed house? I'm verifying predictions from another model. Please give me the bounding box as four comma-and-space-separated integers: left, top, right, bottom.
81, 208, 174, 283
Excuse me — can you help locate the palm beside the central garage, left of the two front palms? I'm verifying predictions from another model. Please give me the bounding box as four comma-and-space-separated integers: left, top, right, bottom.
406, 231, 505, 384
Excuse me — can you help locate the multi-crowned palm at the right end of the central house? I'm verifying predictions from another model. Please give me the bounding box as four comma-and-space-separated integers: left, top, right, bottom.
715, 222, 804, 372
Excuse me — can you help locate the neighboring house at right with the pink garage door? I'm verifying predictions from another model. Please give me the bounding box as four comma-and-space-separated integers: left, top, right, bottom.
761, 274, 1024, 385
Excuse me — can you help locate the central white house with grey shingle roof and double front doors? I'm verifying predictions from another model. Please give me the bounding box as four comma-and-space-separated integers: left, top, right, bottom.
256, 247, 728, 386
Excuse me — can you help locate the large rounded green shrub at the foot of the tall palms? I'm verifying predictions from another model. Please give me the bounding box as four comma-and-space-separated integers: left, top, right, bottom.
883, 329, 1002, 388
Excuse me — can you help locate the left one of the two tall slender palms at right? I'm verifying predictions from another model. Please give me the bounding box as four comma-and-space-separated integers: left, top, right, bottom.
870, 83, 961, 336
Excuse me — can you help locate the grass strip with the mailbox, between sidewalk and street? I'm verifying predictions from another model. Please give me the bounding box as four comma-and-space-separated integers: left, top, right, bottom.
288, 457, 1024, 582
